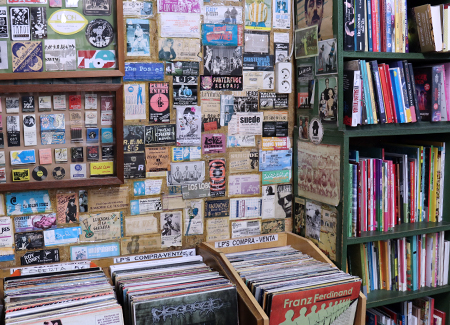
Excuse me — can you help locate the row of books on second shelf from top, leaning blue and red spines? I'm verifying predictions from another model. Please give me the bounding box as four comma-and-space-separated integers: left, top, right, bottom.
343, 60, 450, 126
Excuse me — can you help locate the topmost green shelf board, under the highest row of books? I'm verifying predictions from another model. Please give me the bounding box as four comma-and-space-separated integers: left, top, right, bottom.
341, 51, 450, 61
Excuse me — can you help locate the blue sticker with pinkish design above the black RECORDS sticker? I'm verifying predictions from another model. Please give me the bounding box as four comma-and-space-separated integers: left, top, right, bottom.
202, 24, 242, 46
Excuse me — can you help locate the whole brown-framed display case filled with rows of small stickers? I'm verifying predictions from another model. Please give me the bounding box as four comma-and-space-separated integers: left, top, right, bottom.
0, 84, 124, 191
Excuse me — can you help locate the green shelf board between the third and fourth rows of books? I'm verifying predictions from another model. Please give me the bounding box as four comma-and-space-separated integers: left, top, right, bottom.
347, 222, 450, 245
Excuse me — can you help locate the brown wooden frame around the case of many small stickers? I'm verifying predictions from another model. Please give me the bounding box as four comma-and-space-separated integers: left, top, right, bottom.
0, 84, 124, 192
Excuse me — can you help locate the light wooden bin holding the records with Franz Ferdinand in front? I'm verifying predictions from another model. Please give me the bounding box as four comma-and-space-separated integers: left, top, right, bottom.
198, 233, 366, 325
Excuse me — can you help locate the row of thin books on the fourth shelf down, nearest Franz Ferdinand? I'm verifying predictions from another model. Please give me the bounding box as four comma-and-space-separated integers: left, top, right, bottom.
348, 231, 450, 295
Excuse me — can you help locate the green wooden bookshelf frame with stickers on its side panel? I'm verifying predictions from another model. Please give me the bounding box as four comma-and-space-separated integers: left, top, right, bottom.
294, 0, 450, 318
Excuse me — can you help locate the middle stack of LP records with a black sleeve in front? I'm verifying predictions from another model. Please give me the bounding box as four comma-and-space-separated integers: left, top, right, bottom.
110, 256, 238, 325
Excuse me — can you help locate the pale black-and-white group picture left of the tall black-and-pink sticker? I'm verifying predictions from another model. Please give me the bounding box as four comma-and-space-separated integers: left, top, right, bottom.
167, 161, 205, 185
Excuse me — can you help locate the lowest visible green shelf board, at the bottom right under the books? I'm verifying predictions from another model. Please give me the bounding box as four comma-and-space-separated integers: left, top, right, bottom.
367, 285, 450, 308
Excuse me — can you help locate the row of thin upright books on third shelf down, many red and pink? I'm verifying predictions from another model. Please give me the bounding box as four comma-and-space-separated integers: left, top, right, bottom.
347, 140, 445, 237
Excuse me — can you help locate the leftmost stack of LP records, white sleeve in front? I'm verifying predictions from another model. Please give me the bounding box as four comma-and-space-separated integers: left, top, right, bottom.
5, 267, 123, 325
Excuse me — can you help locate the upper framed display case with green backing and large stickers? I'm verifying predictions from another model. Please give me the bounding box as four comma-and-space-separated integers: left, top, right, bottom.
0, 0, 125, 80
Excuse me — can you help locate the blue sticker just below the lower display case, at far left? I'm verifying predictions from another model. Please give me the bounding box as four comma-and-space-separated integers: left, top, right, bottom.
6, 190, 52, 216
